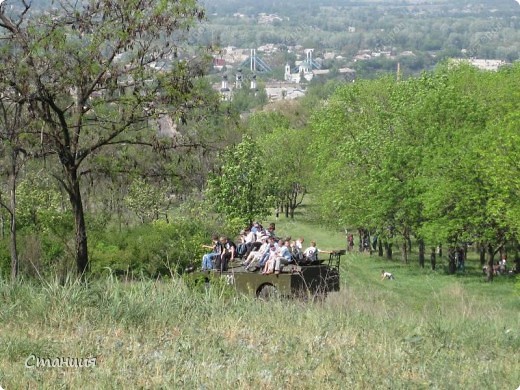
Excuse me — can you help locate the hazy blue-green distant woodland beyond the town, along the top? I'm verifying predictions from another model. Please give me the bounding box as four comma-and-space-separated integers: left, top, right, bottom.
198, 0, 520, 78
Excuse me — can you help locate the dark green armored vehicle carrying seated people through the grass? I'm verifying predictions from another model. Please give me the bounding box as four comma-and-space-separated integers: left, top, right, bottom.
193, 250, 345, 299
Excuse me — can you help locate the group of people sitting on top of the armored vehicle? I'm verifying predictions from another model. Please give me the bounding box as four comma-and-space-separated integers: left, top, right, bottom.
202, 222, 331, 275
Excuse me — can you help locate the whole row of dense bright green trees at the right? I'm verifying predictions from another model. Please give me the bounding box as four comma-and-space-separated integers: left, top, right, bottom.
311, 64, 520, 276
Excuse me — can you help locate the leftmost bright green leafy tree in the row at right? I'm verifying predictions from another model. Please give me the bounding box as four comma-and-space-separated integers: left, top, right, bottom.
311, 78, 404, 251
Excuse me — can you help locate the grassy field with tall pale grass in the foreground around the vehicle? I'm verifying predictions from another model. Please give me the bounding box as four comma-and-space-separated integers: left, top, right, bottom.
0, 220, 520, 390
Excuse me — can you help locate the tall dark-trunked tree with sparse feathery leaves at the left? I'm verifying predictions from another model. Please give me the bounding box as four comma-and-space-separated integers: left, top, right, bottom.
0, 0, 211, 274
